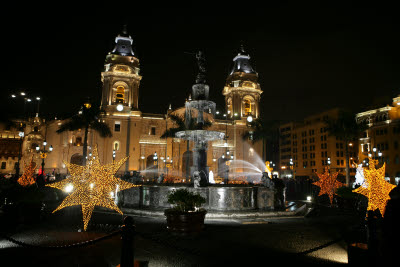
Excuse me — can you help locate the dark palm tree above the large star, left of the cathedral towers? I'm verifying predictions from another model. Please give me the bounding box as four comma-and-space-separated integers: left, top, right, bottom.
57, 104, 112, 166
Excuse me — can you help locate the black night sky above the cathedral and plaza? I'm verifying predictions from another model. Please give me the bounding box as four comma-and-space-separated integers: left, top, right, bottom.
0, 1, 400, 123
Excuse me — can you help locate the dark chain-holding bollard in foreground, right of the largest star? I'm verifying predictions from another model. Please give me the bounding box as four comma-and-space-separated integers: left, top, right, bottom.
120, 216, 135, 267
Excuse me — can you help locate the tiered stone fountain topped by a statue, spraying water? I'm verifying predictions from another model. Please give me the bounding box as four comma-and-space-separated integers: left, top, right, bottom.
123, 52, 282, 216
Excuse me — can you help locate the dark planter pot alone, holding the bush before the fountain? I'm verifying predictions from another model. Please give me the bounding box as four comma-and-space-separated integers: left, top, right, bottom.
164, 209, 207, 234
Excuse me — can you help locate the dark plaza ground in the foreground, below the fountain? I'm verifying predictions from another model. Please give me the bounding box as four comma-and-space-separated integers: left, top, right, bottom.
0, 203, 359, 267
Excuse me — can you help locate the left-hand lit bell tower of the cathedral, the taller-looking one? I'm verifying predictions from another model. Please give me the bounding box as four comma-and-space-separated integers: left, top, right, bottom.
101, 26, 142, 113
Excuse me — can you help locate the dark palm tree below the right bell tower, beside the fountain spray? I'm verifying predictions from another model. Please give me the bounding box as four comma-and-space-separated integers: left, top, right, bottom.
242, 118, 279, 162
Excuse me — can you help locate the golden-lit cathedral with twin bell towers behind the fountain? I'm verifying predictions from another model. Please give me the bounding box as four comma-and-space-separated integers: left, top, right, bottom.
3, 30, 262, 178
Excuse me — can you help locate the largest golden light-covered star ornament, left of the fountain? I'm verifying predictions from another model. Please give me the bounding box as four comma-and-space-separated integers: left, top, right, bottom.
47, 146, 138, 231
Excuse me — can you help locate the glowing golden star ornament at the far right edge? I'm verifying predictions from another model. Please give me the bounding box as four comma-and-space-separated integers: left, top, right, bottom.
353, 158, 396, 217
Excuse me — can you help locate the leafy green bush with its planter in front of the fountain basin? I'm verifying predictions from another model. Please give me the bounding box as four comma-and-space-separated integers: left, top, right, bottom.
164, 189, 207, 234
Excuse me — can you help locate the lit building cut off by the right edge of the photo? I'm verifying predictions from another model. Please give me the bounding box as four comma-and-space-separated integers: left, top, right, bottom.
356, 95, 400, 184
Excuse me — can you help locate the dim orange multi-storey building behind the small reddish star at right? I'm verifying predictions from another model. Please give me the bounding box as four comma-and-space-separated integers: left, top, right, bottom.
278, 109, 357, 178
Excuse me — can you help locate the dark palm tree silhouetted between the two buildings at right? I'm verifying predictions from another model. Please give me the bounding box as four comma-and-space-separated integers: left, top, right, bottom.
324, 110, 368, 186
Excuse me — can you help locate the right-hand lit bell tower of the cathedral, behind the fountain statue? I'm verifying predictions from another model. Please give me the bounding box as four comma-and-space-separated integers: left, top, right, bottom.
222, 45, 262, 119
